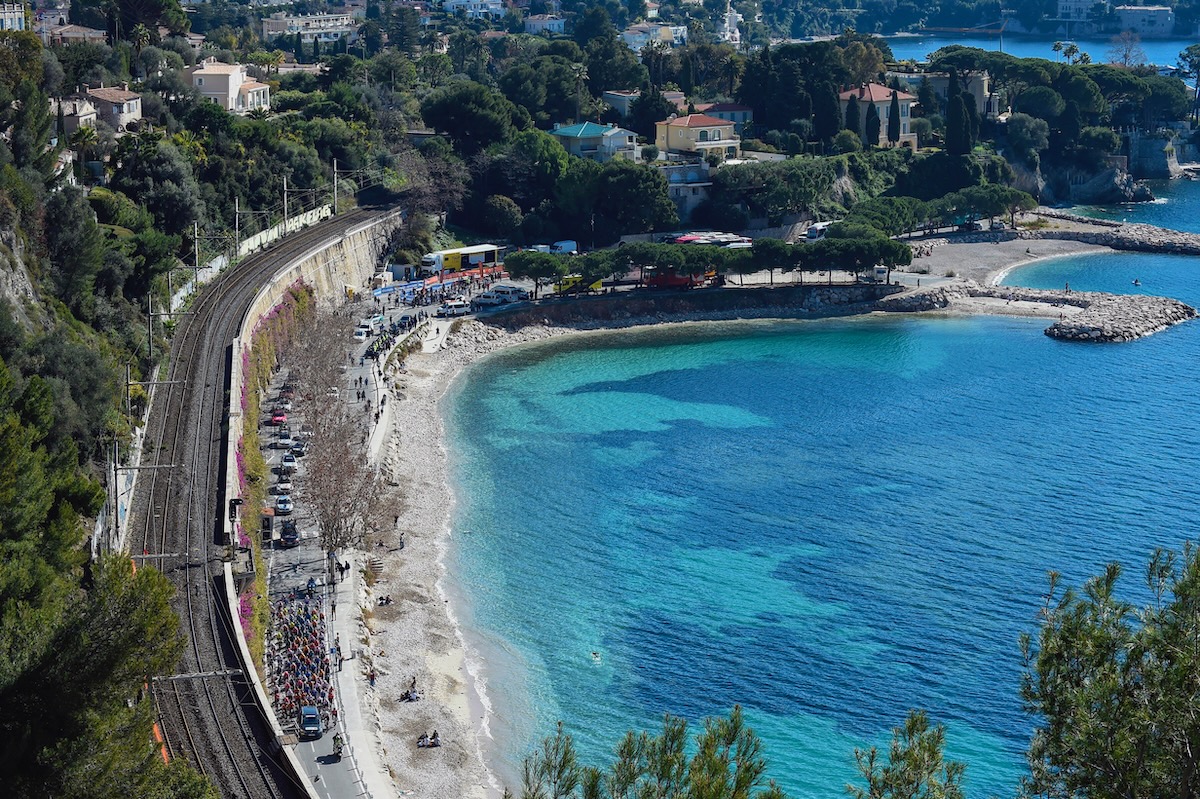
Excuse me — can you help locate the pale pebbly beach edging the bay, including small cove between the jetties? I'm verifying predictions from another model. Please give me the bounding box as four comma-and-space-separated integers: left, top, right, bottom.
348, 230, 1132, 799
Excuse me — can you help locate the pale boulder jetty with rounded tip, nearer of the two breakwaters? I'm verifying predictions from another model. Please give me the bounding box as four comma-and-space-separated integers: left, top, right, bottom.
875, 281, 1196, 342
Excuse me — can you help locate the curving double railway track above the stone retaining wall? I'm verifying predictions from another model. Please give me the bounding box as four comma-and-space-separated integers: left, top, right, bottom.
130, 209, 385, 799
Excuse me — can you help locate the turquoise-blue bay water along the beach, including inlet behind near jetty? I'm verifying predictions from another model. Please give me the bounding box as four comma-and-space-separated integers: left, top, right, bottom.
446, 179, 1200, 799
